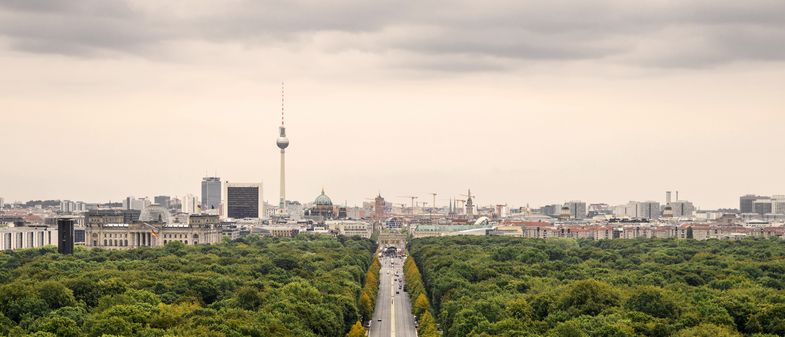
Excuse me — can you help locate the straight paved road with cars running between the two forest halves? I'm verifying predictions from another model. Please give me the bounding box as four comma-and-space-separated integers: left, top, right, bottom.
370, 258, 417, 337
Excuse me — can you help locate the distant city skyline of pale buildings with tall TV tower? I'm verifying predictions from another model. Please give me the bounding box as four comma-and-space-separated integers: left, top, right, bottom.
0, 97, 785, 250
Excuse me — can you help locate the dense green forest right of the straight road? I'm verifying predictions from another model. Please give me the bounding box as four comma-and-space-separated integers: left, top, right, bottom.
410, 236, 785, 337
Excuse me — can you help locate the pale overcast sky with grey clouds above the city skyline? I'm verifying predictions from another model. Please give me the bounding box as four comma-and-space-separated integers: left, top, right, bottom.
0, 0, 785, 209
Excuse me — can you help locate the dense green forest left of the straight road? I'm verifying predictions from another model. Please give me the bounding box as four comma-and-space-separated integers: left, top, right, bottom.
0, 235, 378, 337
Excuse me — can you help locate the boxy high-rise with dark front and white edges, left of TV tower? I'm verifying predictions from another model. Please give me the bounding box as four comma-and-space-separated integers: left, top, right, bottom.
223, 182, 264, 219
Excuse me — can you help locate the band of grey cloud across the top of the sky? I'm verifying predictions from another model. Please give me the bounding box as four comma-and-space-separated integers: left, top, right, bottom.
0, 0, 785, 71
